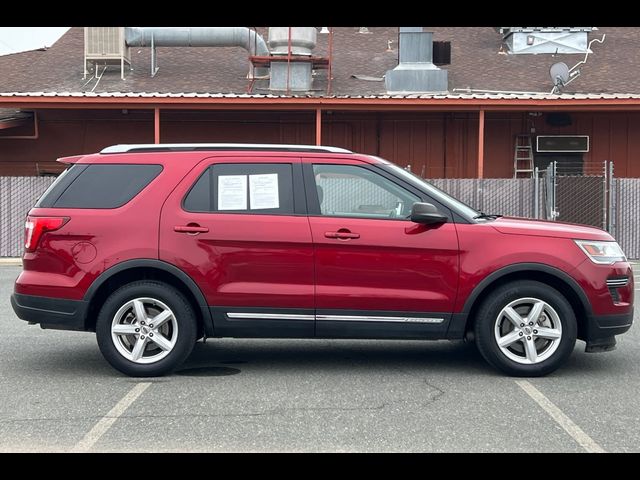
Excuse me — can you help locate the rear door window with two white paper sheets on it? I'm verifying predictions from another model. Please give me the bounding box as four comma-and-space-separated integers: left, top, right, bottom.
183, 163, 294, 215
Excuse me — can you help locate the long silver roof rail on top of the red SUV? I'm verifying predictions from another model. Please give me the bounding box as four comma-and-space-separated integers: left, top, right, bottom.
100, 143, 353, 153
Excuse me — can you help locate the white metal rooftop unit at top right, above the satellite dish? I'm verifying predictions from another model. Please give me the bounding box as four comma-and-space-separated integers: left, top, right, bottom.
496, 27, 596, 55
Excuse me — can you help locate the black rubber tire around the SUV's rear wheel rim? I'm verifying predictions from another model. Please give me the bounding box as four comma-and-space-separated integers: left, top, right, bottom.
96, 280, 198, 377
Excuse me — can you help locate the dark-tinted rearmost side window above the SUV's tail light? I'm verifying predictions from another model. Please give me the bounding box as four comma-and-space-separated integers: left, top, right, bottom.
36, 164, 162, 208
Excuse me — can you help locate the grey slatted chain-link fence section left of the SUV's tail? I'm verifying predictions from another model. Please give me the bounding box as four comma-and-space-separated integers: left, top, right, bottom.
0, 177, 55, 257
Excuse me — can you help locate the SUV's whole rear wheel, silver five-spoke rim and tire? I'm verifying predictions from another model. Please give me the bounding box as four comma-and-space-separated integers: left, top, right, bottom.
96, 281, 197, 377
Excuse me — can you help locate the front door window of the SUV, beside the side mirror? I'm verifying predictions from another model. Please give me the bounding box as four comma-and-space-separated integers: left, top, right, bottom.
313, 164, 420, 219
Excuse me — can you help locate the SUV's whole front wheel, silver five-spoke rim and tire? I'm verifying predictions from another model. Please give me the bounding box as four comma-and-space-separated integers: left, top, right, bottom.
475, 280, 577, 377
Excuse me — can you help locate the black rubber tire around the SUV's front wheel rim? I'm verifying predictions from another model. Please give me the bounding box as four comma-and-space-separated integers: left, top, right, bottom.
474, 280, 578, 377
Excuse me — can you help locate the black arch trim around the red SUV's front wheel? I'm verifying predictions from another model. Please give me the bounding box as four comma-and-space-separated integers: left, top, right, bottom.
449, 263, 591, 338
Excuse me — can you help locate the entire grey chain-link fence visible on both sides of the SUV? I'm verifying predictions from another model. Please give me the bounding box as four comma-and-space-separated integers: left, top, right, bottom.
0, 172, 640, 259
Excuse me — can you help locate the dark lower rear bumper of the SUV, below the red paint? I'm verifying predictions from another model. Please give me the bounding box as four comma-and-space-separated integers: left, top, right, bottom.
11, 293, 87, 330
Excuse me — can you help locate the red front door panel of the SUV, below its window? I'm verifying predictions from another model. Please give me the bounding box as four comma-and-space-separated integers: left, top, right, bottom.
310, 217, 458, 312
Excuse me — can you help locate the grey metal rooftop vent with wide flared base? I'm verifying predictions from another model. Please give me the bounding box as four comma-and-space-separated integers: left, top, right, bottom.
384, 27, 448, 93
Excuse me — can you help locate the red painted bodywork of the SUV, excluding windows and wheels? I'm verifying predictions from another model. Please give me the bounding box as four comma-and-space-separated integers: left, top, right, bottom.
15, 152, 633, 338
